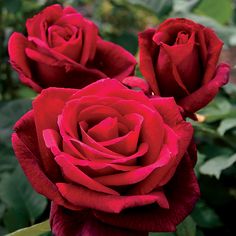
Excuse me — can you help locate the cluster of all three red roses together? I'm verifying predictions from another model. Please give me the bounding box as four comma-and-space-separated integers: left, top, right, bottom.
8, 5, 229, 236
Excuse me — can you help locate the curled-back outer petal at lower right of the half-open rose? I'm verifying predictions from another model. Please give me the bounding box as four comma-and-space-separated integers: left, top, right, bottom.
178, 63, 230, 113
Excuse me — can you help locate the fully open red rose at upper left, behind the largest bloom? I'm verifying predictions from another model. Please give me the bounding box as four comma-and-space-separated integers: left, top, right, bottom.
8, 5, 136, 92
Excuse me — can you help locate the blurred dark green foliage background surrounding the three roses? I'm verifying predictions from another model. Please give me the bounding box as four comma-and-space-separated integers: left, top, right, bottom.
0, 0, 236, 236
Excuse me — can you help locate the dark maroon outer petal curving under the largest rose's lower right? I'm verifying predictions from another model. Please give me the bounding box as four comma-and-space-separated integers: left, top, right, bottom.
95, 156, 199, 232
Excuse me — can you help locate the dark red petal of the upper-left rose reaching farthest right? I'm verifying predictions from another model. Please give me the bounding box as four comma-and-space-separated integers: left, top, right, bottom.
93, 39, 136, 80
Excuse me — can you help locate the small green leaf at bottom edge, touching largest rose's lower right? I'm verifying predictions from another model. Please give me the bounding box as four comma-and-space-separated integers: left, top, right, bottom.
176, 216, 196, 236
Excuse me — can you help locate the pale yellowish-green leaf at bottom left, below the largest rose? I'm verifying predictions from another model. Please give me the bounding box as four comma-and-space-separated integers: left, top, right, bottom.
6, 220, 50, 236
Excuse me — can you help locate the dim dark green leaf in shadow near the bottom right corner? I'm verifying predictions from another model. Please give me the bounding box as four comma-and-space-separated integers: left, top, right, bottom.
191, 200, 222, 228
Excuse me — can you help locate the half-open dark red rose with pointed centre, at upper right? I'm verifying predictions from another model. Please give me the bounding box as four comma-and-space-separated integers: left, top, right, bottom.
139, 18, 229, 112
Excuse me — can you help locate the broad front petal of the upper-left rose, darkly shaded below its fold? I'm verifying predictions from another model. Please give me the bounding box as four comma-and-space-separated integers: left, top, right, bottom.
25, 38, 106, 88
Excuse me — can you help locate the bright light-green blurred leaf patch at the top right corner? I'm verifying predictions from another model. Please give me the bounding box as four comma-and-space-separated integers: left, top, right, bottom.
194, 0, 233, 24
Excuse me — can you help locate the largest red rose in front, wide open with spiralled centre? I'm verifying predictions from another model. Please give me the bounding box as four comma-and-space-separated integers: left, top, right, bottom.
12, 79, 199, 236
